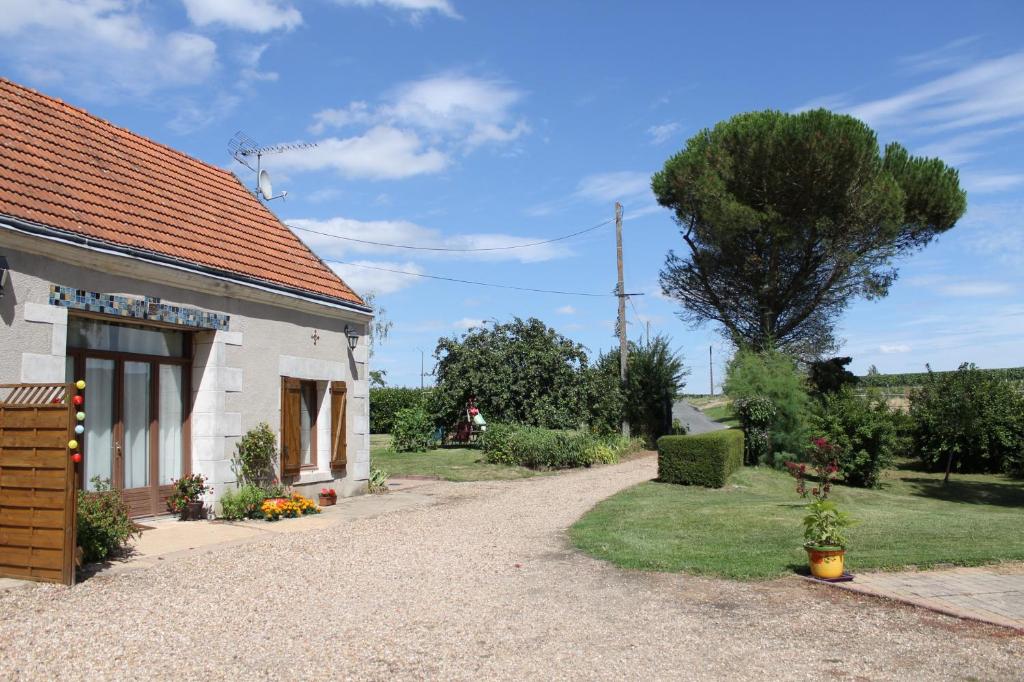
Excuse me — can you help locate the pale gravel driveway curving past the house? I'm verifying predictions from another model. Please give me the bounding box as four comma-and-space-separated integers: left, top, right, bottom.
0, 458, 1024, 680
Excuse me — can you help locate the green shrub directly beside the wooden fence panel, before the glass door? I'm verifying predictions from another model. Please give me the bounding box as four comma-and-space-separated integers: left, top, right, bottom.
77, 476, 141, 562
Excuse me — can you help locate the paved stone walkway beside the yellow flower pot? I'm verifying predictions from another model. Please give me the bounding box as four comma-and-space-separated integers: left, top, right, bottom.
837, 563, 1024, 632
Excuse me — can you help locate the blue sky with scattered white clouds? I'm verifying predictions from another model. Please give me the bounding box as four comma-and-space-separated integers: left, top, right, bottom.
0, 0, 1024, 392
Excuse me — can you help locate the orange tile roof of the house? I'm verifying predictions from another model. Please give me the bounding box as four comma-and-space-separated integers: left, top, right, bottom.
0, 78, 365, 305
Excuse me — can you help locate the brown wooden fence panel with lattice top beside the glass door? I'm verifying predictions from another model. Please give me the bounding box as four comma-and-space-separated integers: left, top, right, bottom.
0, 384, 77, 585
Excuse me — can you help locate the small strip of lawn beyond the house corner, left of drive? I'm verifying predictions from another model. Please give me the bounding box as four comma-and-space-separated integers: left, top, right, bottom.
370, 435, 550, 481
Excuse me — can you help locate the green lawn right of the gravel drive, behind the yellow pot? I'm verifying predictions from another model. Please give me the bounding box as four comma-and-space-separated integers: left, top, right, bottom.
569, 458, 1024, 580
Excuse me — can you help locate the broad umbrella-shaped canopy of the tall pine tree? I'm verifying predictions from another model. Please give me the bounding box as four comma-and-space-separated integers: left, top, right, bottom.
652, 110, 967, 357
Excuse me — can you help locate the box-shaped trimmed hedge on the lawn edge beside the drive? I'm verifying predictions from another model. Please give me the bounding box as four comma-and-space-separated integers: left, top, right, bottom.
657, 429, 743, 487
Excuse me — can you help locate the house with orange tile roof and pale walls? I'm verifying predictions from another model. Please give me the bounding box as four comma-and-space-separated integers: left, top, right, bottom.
0, 79, 372, 516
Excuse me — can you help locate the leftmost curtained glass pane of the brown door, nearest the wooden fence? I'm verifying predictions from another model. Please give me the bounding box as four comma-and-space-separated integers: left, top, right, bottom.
82, 357, 114, 491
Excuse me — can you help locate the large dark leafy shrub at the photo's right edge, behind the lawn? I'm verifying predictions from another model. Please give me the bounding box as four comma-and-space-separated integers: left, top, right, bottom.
910, 363, 1024, 478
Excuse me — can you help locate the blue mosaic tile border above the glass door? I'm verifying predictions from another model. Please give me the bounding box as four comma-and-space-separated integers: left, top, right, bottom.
50, 285, 230, 332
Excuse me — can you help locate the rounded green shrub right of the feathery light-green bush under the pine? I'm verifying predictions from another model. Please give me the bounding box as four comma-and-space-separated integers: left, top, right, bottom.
811, 388, 902, 487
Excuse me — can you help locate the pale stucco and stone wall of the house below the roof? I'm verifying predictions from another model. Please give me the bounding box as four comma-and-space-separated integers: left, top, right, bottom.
0, 229, 370, 502
